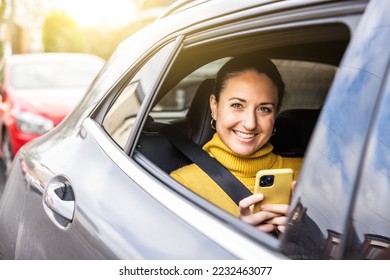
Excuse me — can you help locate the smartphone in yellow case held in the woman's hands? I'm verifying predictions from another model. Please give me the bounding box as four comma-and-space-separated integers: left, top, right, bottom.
254, 168, 294, 212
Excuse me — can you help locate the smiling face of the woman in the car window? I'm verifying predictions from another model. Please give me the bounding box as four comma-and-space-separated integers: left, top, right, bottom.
210, 70, 278, 156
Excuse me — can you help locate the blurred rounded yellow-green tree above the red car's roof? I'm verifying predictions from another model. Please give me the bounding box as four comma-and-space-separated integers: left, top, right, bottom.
42, 11, 84, 52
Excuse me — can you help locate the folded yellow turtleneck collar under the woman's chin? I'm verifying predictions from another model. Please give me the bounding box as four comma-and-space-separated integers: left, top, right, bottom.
203, 133, 278, 177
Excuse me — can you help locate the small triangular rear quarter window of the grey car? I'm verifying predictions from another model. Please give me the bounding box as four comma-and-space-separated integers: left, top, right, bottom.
103, 41, 177, 149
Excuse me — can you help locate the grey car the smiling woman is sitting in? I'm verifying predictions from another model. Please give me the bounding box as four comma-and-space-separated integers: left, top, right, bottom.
0, 0, 390, 260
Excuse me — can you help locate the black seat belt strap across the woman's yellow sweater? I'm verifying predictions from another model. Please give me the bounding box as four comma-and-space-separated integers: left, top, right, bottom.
162, 126, 252, 205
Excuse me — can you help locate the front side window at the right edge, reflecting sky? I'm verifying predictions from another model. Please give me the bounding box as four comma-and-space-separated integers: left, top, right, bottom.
348, 75, 390, 259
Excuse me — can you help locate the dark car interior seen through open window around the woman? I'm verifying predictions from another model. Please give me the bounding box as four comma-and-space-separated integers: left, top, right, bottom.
115, 23, 350, 221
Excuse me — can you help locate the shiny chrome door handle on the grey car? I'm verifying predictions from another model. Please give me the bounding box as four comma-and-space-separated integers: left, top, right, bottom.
43, 182, 75, 222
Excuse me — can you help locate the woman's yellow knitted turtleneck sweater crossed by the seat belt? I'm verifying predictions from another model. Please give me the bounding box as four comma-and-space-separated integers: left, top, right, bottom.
170, 133, 303, 217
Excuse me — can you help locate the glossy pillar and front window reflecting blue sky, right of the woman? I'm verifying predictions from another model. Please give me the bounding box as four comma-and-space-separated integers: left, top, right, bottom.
282, 1, 390, 259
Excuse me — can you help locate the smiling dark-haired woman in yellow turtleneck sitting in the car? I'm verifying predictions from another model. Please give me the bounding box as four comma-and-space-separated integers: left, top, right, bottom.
171, 55, 302, 232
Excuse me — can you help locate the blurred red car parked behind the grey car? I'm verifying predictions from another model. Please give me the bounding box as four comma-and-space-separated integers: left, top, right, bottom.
0, 53, 104, 171
